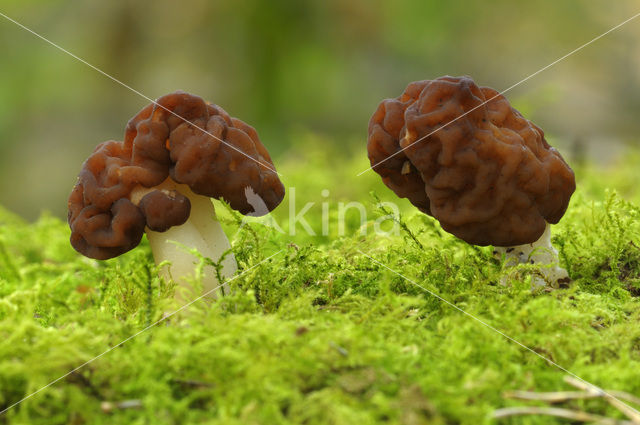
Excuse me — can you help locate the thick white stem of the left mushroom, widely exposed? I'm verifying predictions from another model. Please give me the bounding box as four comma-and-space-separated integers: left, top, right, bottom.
131, 178, 237, 301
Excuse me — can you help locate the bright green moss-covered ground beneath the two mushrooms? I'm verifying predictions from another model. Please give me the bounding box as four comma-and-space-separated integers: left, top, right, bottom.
0, 134, 640, 425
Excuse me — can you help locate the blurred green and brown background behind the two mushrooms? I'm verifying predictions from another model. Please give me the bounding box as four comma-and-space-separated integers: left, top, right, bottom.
0, 0, 640, 219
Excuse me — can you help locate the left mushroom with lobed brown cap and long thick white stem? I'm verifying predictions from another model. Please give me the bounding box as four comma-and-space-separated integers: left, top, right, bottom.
68, 92, 284, 298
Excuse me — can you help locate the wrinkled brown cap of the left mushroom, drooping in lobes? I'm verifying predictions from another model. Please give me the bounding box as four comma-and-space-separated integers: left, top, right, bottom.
69, 92, 284, 259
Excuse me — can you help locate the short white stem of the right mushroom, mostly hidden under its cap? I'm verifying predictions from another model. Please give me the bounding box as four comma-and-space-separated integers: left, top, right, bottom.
493, 223, 570, 287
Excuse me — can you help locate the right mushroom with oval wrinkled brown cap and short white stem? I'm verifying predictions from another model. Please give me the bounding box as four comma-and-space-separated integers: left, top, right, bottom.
367, 76, 576, 285
